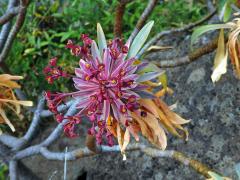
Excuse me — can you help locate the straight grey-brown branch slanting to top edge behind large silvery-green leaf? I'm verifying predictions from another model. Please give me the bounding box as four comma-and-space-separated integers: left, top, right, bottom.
128, 0, 158, 44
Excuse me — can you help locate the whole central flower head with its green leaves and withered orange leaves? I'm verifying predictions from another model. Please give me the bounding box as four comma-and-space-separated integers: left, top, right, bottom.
44, 21, 188, 158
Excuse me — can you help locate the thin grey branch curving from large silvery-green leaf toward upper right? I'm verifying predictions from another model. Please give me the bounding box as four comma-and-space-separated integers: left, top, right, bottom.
136, 9, 216, 59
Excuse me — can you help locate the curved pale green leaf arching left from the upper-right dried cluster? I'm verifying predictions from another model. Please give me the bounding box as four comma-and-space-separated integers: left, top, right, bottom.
191, 24, 232, 44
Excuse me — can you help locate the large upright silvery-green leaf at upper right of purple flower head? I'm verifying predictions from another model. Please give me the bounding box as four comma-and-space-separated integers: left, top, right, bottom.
128, 21, 154, 58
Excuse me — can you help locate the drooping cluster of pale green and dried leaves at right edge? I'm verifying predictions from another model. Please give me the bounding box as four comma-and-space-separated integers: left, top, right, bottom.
191, 18, 240, 82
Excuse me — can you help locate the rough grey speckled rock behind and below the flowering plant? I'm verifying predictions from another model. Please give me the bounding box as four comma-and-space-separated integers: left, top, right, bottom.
24, 28, 240, 180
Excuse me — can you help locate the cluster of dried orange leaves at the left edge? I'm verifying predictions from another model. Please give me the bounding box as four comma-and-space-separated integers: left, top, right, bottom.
0, 74, 32, 134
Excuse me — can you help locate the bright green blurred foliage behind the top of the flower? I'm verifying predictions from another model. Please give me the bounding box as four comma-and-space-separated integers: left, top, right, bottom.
4, 0, 206, 99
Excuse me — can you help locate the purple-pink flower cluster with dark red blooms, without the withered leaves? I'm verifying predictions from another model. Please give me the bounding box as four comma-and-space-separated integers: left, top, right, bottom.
43, 35, 142, 145
